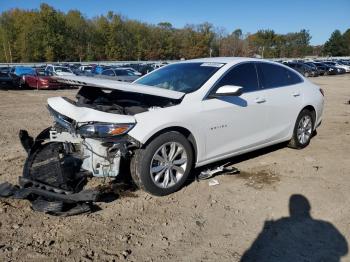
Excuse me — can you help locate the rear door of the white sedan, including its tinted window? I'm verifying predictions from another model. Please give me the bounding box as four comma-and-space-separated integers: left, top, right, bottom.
257, 62, 304, 142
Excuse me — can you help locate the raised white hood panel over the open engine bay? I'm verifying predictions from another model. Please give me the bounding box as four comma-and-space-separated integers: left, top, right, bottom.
55, 76, 185, 99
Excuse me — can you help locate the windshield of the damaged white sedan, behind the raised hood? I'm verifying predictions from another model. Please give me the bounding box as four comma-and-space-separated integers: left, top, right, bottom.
135, 62, 224, 93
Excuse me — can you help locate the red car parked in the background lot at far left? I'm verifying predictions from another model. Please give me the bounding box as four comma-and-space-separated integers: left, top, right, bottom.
21, 70, 65, 90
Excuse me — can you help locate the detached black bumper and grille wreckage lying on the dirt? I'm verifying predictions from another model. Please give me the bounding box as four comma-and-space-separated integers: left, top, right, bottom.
0, 129, 101, 216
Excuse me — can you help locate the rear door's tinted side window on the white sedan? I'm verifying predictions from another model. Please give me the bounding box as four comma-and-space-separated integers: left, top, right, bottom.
257, 63, 302, 88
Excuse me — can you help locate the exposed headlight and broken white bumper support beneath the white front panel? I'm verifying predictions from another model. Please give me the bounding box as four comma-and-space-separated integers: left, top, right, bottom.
48, 103, 140, 177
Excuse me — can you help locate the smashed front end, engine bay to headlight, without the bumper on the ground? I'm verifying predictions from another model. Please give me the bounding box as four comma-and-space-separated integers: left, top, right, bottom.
42, 86, 181, 182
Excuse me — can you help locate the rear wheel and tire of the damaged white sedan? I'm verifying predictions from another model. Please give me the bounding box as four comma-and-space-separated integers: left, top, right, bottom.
288, 109, 315, 149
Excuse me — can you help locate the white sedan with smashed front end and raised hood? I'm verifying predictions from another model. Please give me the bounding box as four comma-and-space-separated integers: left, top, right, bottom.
21, 58, 324, 195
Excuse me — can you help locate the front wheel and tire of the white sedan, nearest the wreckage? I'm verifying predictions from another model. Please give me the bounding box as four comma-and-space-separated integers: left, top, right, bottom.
130, 132, 193, 196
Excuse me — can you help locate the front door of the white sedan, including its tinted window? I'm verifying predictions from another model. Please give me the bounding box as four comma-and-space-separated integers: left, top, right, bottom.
199, 62, 267, 161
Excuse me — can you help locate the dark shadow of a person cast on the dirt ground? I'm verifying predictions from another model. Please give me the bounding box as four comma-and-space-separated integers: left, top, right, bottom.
241, 195, 348, 262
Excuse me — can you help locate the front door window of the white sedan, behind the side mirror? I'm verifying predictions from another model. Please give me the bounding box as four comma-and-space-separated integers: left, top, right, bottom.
215, 63, 259, 93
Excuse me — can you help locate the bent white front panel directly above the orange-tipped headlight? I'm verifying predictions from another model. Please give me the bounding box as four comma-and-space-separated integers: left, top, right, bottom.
47, 97, 136, 124
